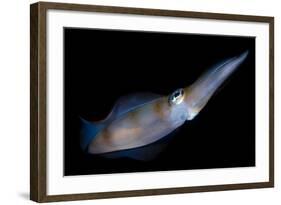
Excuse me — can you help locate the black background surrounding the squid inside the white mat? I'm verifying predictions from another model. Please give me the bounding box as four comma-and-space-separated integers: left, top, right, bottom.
64, 28, 255, 175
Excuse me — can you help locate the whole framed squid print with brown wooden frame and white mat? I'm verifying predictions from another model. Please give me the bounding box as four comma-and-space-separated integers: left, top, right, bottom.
30, 2, 274, 202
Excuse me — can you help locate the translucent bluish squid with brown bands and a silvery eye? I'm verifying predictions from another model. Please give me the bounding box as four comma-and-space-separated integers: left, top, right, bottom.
80, 51, 248, 159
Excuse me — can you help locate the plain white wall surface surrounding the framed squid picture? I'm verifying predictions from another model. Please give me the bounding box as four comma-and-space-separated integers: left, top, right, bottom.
0, 0, 281, 205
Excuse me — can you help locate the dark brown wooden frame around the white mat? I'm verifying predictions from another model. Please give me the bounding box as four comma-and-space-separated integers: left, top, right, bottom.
30, 2, 274, 202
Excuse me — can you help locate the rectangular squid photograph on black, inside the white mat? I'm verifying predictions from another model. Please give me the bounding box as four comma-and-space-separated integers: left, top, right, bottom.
63, 27, 255, 176
